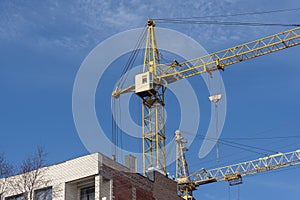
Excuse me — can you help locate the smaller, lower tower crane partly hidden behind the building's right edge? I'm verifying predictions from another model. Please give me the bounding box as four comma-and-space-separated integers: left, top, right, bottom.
175, 130, 300, 200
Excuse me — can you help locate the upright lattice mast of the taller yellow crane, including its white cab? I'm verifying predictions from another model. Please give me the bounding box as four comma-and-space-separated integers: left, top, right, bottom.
135, 20, 166, 175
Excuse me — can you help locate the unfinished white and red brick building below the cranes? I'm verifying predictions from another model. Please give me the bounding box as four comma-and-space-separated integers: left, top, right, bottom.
0, 153, 181, 200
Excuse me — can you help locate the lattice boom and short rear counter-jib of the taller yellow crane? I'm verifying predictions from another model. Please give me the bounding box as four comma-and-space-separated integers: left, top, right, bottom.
112, 27, 300, 97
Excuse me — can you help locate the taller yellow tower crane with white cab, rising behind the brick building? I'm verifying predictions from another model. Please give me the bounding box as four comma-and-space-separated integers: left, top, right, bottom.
112, 19, 300, 174
